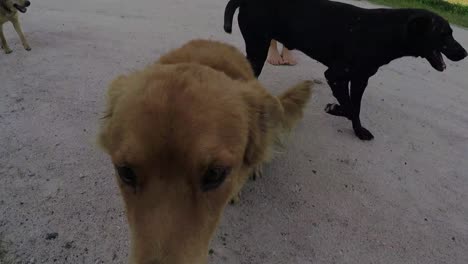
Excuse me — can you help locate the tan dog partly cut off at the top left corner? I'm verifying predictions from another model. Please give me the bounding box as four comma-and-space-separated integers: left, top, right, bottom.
0, 0, 31, 54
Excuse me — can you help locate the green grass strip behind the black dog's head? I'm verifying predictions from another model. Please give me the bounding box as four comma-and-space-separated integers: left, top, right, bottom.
369, 0, 468, 28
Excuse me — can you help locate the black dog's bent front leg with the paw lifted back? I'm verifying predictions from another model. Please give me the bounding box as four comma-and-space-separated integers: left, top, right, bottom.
325, 69, 351, 119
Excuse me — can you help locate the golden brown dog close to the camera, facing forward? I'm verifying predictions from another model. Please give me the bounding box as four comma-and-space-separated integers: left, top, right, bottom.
99, 40, 311, 264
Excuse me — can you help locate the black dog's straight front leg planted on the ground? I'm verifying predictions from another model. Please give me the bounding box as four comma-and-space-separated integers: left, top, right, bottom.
351, 78, 374, 140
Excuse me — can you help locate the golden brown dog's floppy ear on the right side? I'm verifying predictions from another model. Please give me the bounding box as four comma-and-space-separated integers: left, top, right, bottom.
243, 81, 284, 166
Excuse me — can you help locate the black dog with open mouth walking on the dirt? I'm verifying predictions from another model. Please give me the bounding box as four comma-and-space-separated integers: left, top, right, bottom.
224, 0, 467, 140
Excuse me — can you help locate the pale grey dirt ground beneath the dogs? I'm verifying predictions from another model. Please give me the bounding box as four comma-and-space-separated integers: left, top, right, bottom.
0, 0, 468, 264
